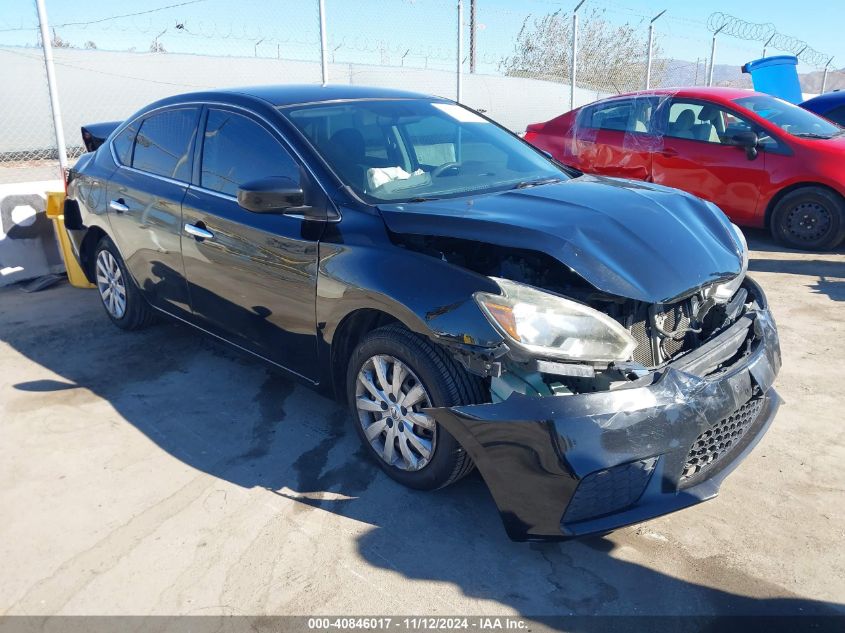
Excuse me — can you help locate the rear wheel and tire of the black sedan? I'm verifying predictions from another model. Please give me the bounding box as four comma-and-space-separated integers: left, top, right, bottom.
92, 236, 154, 330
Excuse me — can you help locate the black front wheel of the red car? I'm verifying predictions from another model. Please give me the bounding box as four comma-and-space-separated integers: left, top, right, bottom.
771, 187, 845, 251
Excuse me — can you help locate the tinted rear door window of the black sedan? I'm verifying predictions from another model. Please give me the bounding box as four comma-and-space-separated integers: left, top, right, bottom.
132, 108, 199, 182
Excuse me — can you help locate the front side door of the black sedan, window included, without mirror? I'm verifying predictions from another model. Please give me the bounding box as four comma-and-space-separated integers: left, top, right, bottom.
182, 106, 328, 379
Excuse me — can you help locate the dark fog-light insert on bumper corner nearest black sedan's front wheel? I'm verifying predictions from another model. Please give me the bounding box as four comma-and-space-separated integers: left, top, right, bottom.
563, 457, 657, 523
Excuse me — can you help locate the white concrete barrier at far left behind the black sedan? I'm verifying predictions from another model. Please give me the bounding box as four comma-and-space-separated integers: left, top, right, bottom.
0, 180, 65, 286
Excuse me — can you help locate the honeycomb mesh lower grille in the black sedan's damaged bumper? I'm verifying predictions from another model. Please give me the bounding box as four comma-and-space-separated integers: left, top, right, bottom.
681, 397, 763, 486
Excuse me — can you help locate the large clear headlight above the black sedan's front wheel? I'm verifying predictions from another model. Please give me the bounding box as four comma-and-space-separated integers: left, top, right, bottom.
475, 277, 637, 363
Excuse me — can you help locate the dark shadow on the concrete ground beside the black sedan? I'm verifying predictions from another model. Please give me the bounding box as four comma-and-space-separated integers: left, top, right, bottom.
0, 286, 845, 616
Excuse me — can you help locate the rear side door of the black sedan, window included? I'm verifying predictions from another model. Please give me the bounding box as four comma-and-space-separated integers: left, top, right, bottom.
108, 106, 200, 316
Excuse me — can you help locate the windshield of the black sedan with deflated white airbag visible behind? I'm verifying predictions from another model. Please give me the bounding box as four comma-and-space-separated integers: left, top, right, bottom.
280, 99, 569, 202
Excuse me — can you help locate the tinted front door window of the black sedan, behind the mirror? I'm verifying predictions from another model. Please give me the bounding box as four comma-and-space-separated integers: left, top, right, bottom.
200, 110, 299, 196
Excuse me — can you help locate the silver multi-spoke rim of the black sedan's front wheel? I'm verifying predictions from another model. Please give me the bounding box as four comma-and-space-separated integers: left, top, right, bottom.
355, 354, 437, 471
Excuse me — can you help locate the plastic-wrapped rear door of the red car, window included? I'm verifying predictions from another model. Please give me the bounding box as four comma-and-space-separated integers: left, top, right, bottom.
572, 97, 656, 180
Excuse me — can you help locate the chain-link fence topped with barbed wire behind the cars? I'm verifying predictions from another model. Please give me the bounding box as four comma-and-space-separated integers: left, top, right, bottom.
0, 0, 845, 183
